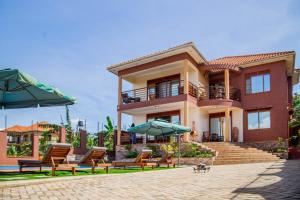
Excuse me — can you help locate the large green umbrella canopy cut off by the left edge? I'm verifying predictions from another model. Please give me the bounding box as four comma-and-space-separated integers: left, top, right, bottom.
0, 69, 76, 109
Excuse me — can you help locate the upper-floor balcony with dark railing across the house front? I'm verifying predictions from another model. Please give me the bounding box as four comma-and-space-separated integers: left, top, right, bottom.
119, 80, 241, 109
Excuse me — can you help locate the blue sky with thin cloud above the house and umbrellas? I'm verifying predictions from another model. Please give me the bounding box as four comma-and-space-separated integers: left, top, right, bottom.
0, 0, 300, 132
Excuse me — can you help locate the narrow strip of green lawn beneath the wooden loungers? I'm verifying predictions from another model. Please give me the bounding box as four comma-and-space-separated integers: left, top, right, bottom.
0, 167, 172, 182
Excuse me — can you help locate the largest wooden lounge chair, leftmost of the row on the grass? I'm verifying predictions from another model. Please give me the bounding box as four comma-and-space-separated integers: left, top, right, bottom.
18, 143, 77, 176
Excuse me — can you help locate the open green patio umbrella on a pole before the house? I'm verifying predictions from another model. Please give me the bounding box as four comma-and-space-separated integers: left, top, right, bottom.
127, 120, 191, 164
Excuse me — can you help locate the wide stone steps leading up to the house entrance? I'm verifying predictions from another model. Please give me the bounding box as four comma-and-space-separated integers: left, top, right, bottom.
202, 142, 279, 165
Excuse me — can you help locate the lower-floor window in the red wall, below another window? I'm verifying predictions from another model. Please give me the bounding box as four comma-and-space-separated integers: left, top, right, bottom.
248, 111, 270, 130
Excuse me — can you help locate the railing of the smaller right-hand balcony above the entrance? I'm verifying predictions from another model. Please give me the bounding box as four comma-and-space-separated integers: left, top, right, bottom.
199, 86, 241, 101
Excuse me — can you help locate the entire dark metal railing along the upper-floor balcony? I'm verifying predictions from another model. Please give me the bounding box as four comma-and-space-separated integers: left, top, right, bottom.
122, 80, 241, 104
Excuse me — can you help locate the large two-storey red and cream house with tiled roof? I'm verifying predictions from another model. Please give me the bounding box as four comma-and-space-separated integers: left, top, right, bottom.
107, 43, 299, 148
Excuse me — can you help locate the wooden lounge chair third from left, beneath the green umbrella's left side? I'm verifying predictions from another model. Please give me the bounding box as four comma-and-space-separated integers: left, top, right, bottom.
112, 149, 157, 170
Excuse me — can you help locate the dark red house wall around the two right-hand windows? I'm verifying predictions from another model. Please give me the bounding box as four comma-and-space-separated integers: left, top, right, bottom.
231, 61, 291, 142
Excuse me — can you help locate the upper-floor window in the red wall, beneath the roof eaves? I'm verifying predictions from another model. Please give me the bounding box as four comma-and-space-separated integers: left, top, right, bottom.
246, 73, 270, 94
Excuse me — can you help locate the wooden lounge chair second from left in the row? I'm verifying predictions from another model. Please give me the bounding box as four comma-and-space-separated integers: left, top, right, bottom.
79, 147, 111, 173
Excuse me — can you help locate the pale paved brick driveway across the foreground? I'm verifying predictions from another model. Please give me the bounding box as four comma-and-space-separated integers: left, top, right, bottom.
0, 161, 300, 200
